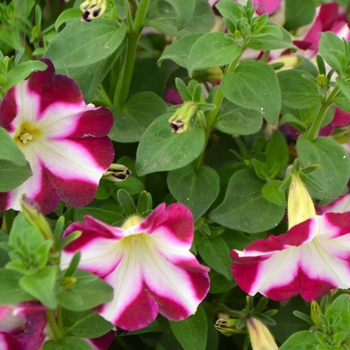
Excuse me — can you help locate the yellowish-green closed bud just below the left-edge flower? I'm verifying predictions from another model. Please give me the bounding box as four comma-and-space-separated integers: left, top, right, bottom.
21, 195, 53, 240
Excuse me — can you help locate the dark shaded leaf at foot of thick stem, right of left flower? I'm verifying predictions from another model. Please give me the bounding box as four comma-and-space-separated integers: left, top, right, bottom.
109, 92, 167, 142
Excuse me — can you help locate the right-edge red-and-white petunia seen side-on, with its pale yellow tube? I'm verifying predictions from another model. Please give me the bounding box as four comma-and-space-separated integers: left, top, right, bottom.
231, 170, 350, 301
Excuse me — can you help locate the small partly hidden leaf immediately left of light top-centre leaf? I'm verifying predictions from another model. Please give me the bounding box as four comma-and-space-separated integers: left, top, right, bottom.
158, 33, 203, 68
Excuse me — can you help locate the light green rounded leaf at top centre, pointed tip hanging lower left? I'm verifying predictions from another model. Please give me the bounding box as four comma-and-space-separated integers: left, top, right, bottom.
188, 32, 242, 76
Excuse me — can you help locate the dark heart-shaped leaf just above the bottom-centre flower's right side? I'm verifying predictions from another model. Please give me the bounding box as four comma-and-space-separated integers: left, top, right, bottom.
167, 164, 220, 221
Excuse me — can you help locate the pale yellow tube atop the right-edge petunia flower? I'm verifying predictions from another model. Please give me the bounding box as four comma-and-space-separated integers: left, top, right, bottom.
288, 171, 316, 229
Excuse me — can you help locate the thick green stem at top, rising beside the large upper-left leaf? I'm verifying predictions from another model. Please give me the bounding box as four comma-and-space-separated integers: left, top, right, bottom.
114, 0, 149, 108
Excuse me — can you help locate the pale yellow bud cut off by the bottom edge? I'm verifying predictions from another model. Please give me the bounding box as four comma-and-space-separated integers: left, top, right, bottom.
247, 317, 278, 350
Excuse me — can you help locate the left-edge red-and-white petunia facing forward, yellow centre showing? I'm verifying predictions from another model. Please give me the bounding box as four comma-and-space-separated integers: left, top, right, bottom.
0, 59, 114, 214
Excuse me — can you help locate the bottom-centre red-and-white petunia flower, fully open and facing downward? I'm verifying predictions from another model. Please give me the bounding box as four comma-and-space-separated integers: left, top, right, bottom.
61, 203, 209, 330
